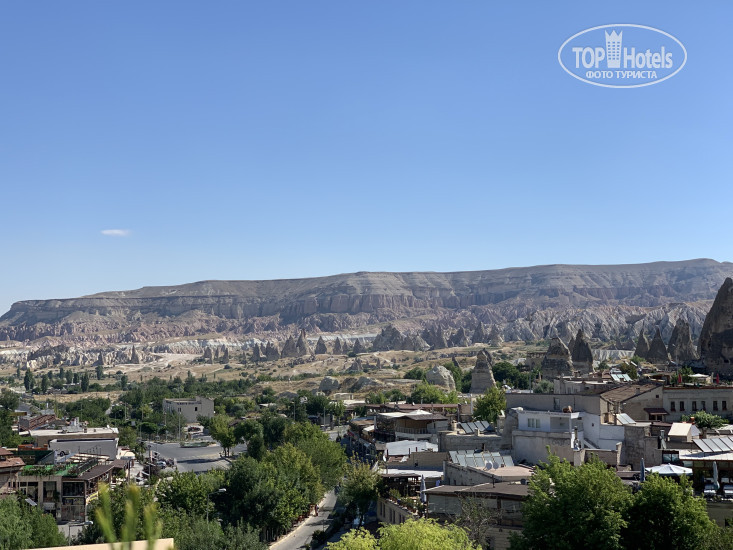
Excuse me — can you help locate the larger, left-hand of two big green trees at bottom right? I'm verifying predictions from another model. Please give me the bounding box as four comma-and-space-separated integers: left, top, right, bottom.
511, 455, 632, 550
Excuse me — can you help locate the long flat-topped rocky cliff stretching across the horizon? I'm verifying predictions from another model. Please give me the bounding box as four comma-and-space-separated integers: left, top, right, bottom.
0, 260, 733, 343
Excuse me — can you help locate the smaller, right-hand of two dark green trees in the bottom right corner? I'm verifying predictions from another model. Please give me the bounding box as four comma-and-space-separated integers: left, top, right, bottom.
622, 474, 715, 550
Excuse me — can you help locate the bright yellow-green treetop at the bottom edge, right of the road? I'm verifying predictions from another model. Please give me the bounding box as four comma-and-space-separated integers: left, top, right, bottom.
379, 519, 479, 550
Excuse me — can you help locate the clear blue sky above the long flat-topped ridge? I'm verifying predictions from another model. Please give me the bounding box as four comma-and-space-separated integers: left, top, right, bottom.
0, 0, 733, 311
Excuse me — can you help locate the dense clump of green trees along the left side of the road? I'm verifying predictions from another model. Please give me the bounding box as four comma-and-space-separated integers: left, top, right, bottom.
81, 412, 346, 550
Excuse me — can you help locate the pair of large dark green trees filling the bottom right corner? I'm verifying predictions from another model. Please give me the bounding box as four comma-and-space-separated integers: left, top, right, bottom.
511, 456, 733, 550
